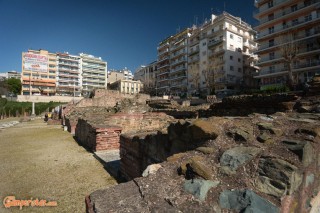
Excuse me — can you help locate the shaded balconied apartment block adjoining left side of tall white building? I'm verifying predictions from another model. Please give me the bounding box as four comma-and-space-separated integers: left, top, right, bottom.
156, 28, 192, 95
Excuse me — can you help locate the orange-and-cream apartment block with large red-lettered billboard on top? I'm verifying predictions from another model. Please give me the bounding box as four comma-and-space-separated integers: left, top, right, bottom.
21, 49, 57, 95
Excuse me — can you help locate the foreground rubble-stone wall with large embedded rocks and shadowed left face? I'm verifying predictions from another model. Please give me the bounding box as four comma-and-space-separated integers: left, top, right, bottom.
86, 112, 320, 213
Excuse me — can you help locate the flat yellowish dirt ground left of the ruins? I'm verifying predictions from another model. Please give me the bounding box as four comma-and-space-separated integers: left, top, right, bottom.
0, 119, 116, 212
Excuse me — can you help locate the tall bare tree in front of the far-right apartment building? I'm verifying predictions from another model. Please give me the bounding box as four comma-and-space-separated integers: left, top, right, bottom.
280, 34, 298, 89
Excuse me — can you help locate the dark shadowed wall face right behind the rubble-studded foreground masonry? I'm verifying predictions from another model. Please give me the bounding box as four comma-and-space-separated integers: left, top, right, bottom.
120, 120, 218, 180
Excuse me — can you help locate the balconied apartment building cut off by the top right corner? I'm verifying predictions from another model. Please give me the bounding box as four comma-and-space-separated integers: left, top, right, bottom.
254, 0, 320, 89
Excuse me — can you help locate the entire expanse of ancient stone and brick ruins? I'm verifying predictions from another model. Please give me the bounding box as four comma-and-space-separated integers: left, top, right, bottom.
58, 88, 320, 212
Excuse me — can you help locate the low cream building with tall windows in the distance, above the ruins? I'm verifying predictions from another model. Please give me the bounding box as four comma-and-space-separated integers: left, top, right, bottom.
109, 80, 143, 95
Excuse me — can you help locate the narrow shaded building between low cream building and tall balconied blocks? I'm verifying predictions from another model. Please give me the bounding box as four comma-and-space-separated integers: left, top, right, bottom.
134, 61, 157, 95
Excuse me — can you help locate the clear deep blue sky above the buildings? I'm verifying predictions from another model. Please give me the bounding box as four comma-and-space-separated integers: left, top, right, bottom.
0, 0, 257, 72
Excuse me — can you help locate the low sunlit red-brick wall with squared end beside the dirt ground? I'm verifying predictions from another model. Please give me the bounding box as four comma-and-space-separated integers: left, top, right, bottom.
74, 113, 171, 151
